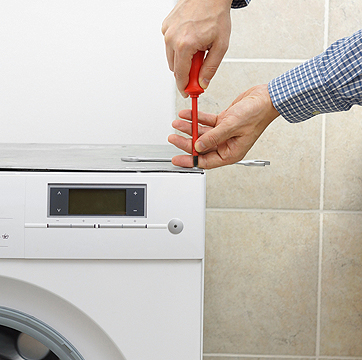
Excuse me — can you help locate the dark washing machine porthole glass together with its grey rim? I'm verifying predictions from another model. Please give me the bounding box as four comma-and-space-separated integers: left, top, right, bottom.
0, 307, 84, 360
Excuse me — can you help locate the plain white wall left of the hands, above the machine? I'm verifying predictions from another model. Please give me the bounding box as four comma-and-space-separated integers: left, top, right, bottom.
0, 0, 174, 144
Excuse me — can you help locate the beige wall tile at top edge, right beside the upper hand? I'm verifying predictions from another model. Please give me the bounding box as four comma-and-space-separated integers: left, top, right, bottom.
226, 0, 324, 59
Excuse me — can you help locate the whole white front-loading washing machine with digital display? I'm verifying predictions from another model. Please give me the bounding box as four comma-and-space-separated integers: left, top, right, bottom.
0, 144, 205, 360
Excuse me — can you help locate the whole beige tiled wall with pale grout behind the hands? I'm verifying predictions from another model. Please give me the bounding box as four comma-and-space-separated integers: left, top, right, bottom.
177, 0, 362, 360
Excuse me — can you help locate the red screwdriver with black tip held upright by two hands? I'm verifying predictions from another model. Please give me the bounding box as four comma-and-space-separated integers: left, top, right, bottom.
185, 51, 205, 167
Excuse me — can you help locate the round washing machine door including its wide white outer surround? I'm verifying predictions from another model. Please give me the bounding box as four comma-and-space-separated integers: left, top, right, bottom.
0, 272, 125, 360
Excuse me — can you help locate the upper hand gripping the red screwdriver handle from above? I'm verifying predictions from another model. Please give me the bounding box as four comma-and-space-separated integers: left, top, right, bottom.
162, 0, 232, 97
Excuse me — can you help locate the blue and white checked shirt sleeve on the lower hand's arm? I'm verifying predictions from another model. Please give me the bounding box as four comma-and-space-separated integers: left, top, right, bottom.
268, 29, 362, 122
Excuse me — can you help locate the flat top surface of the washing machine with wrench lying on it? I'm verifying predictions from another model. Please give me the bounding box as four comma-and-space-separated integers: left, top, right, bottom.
0, 144, 203, 173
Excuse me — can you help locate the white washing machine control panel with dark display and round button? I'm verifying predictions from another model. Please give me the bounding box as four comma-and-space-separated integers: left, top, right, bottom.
0, 171, 205, 260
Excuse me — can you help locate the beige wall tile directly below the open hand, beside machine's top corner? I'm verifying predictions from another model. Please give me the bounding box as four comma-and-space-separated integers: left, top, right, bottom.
207, 114, 321, 209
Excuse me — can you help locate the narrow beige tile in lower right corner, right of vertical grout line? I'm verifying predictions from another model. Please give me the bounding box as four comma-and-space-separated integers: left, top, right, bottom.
321, 214, 362, 357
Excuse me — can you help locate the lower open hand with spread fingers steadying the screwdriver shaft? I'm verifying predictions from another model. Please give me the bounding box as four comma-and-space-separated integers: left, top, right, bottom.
168, 84, 279, 169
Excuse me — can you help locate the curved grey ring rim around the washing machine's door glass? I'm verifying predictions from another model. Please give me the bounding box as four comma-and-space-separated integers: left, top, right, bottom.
0, 306, 84, 360
